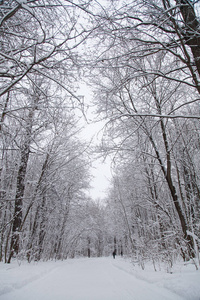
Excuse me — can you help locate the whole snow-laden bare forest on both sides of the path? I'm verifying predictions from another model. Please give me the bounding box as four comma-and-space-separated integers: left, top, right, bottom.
0, 0, 200, 268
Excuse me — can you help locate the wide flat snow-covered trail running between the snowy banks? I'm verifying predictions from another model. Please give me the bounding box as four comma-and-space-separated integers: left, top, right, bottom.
0, 258, 183, 300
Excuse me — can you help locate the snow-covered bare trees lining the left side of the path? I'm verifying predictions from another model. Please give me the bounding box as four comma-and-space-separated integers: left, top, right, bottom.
0, 1, 90, 262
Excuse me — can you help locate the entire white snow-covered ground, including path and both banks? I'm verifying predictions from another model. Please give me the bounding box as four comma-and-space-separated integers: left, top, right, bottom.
0, 257, 200, 300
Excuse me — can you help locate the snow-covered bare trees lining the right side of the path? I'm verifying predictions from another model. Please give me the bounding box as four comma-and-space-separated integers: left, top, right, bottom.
88, 0, 200, 266
